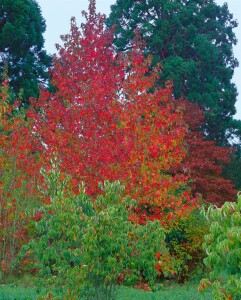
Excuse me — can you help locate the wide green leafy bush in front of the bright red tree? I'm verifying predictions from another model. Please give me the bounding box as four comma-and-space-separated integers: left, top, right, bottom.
19, 163, 168, 299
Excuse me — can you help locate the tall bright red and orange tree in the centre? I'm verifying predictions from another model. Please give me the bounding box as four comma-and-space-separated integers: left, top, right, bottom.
28, 1, 196, 222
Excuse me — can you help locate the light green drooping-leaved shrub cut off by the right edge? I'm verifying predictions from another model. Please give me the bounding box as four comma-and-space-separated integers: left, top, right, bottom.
199, 194, 241, 300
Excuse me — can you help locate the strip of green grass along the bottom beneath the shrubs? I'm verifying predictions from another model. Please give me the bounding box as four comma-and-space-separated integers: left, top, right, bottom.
0, 283, 212, 300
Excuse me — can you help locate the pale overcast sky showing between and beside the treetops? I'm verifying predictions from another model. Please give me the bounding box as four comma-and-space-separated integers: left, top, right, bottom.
37, 0, 241, 119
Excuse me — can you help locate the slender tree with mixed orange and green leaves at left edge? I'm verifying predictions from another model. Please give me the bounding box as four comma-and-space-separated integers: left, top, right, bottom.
0, 78, 41, 272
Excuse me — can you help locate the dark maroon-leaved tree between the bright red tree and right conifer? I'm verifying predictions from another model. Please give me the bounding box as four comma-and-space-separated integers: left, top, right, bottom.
174, 99, 237, 206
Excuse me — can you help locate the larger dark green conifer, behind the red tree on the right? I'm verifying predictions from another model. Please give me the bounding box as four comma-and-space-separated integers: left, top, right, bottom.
106, 0, 241, 145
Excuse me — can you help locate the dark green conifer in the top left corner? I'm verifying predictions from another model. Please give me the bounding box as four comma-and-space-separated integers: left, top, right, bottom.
0, 0, 51, 106
